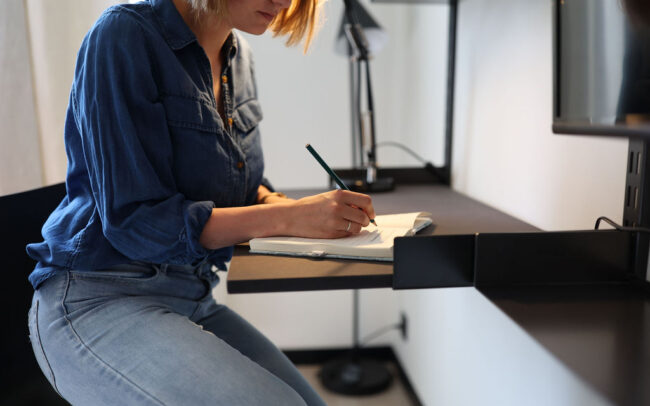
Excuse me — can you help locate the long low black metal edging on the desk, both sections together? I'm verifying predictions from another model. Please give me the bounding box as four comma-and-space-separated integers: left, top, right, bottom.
393, 230, 635, 289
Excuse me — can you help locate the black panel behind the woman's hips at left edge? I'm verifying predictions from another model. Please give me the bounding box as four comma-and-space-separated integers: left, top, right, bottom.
0, 183, 67, 405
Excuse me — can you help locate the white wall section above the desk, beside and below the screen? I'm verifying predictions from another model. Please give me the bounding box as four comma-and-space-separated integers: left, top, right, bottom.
453, 0, 627, 230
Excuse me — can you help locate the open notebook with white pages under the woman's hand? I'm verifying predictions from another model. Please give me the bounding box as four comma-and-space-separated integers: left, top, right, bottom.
250, 212, 431, 261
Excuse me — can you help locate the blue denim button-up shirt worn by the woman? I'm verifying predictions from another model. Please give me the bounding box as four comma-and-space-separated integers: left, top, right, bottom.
27, 0, 270, 288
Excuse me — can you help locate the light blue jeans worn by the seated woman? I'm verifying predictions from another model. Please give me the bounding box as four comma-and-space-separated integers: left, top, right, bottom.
29, 264, 324, 406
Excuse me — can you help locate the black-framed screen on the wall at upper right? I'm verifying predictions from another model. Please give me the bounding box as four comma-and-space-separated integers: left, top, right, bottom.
553, 0, 650, 138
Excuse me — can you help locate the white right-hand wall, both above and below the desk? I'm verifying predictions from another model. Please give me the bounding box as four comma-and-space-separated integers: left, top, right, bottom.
395, 0, 627, 405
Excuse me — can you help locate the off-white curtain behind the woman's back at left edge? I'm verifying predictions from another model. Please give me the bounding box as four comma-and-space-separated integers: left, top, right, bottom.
0, 0, 118, 195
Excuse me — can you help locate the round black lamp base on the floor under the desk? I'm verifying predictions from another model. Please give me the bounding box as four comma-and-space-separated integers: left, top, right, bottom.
318, 357, 393, 396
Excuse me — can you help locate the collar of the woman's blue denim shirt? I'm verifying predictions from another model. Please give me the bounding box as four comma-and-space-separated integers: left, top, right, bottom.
150, 0, 238, 62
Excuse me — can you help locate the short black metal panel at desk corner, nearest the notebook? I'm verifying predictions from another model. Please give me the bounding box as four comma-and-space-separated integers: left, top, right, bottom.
393, 234, 474, 289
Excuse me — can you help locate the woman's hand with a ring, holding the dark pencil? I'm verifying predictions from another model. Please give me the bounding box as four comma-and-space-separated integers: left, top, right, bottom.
285, 189, 375, 238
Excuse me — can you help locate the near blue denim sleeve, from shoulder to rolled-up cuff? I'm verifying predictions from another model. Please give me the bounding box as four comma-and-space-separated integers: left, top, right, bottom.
72, 13, 214, 263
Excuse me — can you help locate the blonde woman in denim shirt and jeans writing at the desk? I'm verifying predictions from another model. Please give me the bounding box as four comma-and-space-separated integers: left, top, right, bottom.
28, 0, 374, 405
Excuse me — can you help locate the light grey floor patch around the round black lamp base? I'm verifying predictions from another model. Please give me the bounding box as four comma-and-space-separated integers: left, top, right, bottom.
298, 364, 413, 406
